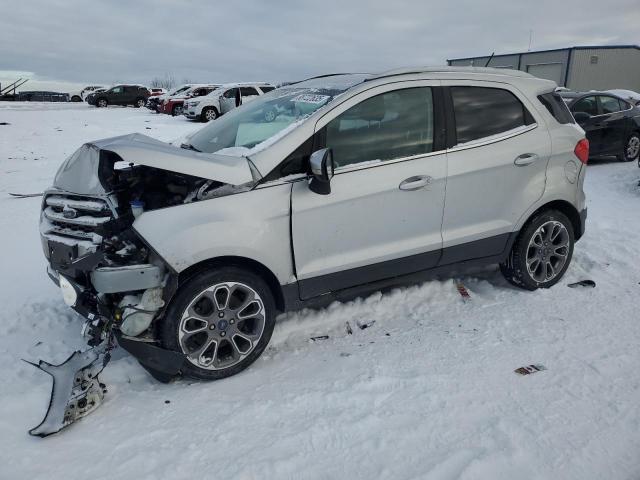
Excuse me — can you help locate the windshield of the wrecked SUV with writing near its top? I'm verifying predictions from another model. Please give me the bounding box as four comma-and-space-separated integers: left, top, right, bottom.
189, 85, 346, 156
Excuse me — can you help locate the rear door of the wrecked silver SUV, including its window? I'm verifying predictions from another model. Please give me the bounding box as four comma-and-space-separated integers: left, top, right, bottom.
441, 81, 551, 265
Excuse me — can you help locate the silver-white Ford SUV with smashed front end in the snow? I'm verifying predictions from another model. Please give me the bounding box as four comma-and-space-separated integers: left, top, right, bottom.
40, 67, 589, 379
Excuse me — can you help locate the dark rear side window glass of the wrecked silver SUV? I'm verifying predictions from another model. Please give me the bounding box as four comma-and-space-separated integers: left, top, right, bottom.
451, 87, 535, 144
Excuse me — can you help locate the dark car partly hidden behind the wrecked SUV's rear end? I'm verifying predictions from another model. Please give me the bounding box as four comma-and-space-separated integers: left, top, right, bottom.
559, 92, 640, 162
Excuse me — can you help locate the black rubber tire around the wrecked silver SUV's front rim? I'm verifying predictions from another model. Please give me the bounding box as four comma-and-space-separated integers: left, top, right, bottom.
158, 266, 276, 380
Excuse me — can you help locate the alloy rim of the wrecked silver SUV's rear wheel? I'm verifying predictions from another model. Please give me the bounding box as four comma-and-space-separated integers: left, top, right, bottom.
526, 220, 570, 283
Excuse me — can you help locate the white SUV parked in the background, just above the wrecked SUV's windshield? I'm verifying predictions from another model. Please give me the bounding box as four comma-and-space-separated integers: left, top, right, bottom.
183, 83, 275, 122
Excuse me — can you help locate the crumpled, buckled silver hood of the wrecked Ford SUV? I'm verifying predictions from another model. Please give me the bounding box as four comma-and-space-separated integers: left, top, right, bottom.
53, 133, 259, 194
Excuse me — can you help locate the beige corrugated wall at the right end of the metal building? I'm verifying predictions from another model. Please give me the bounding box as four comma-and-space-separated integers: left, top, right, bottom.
567, 48, 640, 92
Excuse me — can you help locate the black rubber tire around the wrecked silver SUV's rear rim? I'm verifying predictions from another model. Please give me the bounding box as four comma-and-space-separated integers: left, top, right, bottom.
500, 210, 575, 290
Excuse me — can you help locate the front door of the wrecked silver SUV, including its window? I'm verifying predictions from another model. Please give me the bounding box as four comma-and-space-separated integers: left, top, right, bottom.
292, 82, 447, 299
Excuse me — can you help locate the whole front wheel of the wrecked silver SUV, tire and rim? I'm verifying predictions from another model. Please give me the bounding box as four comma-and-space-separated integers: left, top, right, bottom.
158, 266, 276, 380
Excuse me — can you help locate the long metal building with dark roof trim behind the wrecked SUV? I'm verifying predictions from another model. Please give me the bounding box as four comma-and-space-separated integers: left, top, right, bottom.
447, 45, 640, 92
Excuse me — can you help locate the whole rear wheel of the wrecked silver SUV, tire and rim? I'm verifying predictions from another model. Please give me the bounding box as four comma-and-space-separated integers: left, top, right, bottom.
500, 210, 575, 290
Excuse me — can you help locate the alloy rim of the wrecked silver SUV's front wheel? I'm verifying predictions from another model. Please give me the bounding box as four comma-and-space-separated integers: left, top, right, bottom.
178, 282, 265, 370
